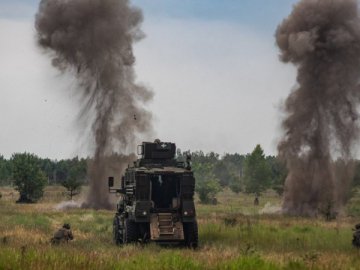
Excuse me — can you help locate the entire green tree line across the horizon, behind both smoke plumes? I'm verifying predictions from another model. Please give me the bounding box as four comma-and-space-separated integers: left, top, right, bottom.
0, 145, 360, 203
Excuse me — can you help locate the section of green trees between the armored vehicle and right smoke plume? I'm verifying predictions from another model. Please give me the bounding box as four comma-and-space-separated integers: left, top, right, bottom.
177, 145, 287, 203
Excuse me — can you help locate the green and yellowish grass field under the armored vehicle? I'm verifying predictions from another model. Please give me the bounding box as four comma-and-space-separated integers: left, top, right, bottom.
0, 187, 360, 270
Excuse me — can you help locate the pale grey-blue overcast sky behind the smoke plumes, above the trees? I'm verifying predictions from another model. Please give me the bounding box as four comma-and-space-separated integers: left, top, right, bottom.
0, 0, 296, 159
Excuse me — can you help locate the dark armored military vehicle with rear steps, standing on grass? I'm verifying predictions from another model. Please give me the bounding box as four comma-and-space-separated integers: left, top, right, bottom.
109, 140, 198, 248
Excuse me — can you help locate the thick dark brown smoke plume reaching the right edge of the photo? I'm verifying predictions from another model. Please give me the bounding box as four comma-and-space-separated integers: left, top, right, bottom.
276, 0, 360, 215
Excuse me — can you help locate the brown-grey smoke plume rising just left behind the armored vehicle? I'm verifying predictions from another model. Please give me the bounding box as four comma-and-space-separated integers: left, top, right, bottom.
35, 0, 152, 208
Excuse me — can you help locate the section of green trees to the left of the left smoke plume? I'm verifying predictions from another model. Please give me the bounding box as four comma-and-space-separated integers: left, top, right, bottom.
0, 153, 90, 203
